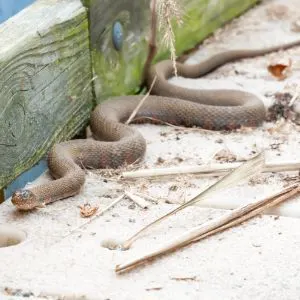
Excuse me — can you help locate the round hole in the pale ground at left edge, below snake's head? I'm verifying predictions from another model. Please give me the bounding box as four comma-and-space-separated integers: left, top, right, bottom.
0, 225, 26, 248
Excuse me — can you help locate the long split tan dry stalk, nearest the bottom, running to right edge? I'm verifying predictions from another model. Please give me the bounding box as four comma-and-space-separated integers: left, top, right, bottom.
115, 182, 300, 273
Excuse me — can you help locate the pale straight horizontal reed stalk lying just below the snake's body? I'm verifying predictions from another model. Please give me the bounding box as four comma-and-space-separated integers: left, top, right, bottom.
121, 162, 300, 178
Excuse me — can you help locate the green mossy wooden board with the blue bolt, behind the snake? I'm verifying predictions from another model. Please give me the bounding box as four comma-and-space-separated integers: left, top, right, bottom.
88, 0, 258, 102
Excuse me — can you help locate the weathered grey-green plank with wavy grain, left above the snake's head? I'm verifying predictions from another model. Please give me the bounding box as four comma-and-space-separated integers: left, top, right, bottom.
0, 0, 93, 188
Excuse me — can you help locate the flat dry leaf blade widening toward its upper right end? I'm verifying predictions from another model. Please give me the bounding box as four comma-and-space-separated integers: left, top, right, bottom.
121, 153, 264, 249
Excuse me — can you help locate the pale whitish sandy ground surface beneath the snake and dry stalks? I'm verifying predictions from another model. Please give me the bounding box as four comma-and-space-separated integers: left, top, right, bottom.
0, 0, 300, 299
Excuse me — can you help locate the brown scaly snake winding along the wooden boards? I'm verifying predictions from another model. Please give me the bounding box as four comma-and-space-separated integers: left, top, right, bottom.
12, 41, 299, 210
